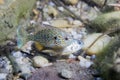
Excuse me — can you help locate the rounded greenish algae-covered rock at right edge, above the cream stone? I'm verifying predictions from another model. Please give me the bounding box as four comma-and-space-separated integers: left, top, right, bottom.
90, 11, 120, 31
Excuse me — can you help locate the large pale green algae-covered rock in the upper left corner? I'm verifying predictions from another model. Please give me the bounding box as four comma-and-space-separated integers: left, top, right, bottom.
0, 0, 36, 44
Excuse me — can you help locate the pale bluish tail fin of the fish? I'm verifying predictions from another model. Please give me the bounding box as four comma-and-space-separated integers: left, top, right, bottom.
17, 25, 27, 49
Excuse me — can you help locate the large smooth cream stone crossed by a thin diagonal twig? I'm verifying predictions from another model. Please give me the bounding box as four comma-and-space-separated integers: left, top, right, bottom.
82, 33, 112, 55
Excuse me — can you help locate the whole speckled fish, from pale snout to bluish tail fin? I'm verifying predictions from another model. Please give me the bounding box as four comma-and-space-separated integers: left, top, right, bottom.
17, 26, 80, 50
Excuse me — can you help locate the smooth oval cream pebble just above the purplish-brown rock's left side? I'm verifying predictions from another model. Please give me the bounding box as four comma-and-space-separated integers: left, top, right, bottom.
33, 56, 49, 67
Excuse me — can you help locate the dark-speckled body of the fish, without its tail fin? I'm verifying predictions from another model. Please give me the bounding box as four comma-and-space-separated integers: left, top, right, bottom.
28, 27, 73, 48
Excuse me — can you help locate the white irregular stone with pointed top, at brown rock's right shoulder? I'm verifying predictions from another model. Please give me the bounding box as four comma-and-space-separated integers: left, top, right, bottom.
78, 56, 93, 68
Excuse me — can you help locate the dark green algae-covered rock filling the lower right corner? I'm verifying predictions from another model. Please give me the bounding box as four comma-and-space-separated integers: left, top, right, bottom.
95, 36, 120, 80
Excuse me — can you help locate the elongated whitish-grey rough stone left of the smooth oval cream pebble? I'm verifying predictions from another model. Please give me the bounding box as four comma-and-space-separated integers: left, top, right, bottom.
12, 51, 34, 77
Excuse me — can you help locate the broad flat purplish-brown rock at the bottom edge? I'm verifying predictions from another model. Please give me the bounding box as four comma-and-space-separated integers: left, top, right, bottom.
28, 61, 93, 80
